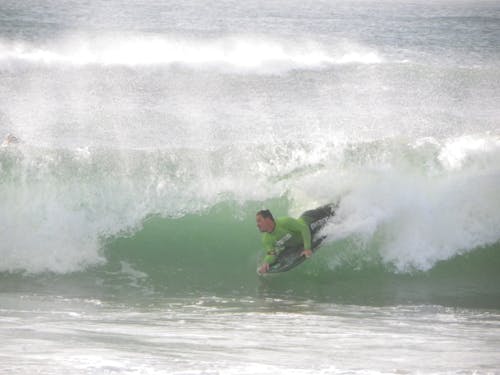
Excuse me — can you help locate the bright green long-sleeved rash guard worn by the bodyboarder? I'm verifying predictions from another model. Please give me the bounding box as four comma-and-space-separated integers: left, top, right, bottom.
262, 217, 311, 264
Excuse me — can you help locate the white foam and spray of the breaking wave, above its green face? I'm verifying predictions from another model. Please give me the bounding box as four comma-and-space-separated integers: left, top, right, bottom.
1, 135, 500, 272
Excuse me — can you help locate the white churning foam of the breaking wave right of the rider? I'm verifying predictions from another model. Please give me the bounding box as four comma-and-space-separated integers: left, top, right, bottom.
320, 136, 500, 272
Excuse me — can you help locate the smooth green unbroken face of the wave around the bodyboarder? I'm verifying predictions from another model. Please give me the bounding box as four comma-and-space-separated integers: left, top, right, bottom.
99, 201, 500, 307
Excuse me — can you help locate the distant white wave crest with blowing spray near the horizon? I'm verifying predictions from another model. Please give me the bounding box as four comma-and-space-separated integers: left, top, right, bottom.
0, 36, 382, 71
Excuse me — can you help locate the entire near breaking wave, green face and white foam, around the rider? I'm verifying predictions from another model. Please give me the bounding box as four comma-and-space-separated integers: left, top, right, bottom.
0, 135, 500, 307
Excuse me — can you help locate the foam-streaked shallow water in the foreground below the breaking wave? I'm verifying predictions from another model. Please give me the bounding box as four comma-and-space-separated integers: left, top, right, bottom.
0, 296, 500, 374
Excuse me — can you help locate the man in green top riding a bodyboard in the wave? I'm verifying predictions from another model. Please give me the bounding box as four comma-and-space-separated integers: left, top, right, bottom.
256, 204, 336, 274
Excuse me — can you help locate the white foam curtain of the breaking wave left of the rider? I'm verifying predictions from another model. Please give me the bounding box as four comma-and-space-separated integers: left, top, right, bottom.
0, 146, 276, 273
